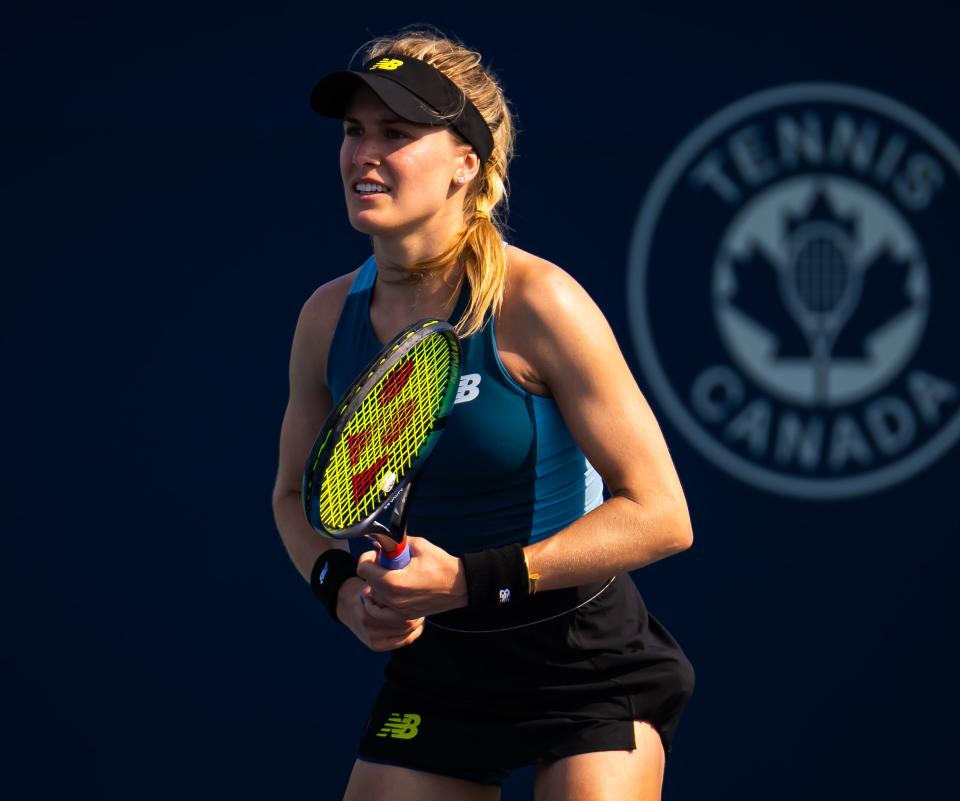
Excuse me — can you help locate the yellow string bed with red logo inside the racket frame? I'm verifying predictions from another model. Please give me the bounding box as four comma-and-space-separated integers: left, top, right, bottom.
319, 336, 452, 529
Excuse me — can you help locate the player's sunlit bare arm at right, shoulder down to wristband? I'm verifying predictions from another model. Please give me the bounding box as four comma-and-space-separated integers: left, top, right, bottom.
521, 265, 693, 590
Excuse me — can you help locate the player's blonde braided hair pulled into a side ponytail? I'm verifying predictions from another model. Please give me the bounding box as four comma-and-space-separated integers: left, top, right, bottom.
363, 28, 514, 337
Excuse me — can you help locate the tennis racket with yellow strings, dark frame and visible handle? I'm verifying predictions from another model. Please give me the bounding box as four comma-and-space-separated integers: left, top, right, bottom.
301, 320, 461, 569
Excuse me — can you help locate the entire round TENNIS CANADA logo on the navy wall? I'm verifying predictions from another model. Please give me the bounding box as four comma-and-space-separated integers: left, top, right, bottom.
627, 84, 960, 498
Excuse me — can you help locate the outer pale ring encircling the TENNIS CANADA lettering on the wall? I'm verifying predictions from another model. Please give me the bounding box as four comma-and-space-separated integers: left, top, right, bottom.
627, 83, 960, 499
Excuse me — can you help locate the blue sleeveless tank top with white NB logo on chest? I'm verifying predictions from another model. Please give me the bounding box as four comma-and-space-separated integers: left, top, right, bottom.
327, 256, 603, 555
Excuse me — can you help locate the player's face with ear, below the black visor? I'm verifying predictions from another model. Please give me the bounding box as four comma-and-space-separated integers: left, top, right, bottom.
340, 87, 479, 236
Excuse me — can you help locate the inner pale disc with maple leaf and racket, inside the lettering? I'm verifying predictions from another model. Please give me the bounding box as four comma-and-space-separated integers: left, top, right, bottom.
711, 174, 929, 407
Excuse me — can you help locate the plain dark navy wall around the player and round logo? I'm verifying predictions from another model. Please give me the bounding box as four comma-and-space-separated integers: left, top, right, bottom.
0, 2, 960, 799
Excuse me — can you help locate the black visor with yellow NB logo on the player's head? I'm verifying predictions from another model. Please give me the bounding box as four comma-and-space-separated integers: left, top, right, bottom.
310, 54, 493, 164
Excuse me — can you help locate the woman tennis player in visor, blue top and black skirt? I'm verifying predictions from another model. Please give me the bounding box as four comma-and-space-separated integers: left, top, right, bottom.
273, 30, 693, 801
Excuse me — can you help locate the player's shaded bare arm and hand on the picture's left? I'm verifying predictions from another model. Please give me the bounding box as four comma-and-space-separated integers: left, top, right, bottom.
273, 274, 423, 651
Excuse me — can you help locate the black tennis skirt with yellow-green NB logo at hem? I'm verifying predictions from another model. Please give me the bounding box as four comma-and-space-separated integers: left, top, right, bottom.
358, 575, 694, 785
